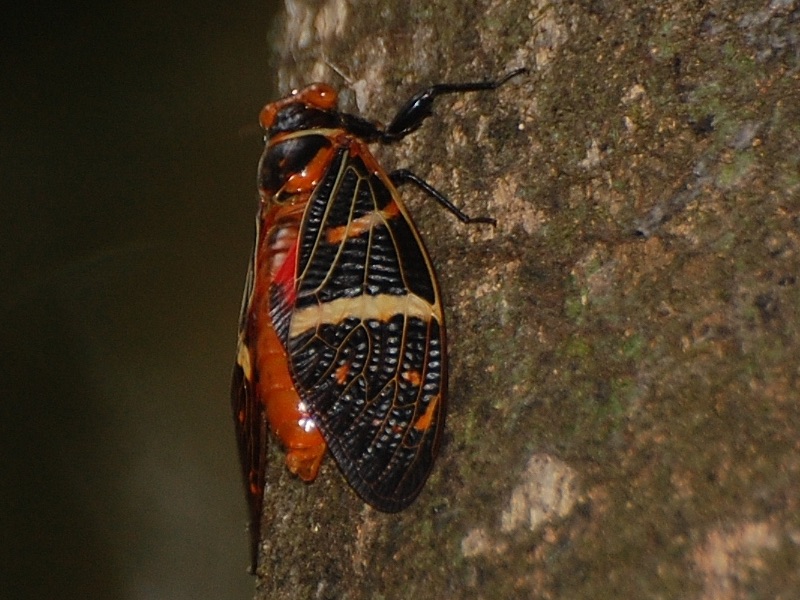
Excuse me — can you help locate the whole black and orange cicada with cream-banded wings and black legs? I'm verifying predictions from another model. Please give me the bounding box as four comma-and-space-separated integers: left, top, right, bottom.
232, 69, 523, 569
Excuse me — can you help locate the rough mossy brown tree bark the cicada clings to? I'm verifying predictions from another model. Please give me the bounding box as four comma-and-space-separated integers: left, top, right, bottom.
257, 0, 800, 600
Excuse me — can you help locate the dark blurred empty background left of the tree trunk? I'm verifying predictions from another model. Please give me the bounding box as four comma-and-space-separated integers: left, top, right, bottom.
0, 2, 277, 600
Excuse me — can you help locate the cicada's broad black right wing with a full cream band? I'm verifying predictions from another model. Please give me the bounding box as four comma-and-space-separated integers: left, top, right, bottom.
285, 148, 446, 511
